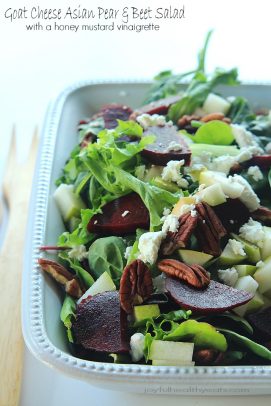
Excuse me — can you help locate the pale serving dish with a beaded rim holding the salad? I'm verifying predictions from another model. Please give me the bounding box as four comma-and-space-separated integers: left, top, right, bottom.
22, 82, 271, 396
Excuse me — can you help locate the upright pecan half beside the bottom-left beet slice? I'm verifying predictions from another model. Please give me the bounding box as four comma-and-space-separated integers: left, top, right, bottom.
119, 259, 153, 313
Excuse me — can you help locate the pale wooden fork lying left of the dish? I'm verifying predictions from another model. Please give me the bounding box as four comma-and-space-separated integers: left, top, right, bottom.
0, 132, 38, 406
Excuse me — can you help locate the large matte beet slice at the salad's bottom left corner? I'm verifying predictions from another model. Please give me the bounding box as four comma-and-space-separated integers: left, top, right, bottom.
73, 292, 130, 353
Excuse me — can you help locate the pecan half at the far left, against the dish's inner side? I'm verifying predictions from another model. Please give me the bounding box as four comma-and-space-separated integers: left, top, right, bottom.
38, 258, 83, 298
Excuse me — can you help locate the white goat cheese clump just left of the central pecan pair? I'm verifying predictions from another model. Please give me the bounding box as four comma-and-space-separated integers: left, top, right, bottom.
138, 231, 165, 265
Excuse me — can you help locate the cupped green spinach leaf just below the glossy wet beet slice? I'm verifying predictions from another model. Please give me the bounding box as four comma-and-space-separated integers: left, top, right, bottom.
88, 236, 126, 286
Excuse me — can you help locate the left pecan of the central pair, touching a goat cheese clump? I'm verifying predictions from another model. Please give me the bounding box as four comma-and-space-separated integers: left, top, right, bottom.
161, 212, 198, 255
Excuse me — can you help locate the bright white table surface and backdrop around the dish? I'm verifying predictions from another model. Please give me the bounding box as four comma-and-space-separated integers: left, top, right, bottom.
0, 0, 271, 406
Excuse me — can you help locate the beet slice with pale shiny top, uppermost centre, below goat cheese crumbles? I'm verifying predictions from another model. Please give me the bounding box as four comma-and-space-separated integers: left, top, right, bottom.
141, 125, 191, 166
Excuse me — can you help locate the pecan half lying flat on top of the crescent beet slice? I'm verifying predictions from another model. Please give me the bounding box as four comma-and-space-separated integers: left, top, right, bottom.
157, 259, 210, 289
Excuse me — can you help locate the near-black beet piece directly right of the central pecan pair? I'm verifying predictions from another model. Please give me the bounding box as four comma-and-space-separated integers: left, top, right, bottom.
213, 199, 251, 233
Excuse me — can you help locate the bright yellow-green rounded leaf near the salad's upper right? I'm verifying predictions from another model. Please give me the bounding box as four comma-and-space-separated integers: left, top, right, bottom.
189, 120, 234, 145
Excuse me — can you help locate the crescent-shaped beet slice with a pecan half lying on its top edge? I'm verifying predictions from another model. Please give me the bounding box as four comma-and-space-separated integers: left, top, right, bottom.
166, 276, 253, 314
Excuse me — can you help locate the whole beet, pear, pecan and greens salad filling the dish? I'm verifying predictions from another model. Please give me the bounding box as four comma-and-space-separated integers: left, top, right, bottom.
39, 33, 271, 366
